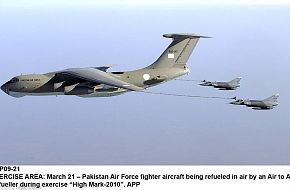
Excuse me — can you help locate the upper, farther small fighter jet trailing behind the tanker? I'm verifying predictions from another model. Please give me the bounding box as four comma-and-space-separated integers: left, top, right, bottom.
199, 77, 242, 90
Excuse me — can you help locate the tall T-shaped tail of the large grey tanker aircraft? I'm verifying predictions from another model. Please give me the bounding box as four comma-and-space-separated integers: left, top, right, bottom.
148, 33, 209, 69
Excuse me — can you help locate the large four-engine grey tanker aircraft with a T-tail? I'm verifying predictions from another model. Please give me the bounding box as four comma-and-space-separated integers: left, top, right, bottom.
1, 33, 208, 97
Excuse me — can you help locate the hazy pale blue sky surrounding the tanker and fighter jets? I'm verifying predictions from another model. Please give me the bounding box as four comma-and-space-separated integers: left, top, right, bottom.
0, 0, 290, 164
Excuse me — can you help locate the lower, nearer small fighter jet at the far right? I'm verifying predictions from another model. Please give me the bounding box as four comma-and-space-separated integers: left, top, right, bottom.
230, 94, 279, 110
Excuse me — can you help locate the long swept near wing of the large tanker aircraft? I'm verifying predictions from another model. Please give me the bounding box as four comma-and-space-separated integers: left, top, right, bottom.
58, 68, 144, 91
